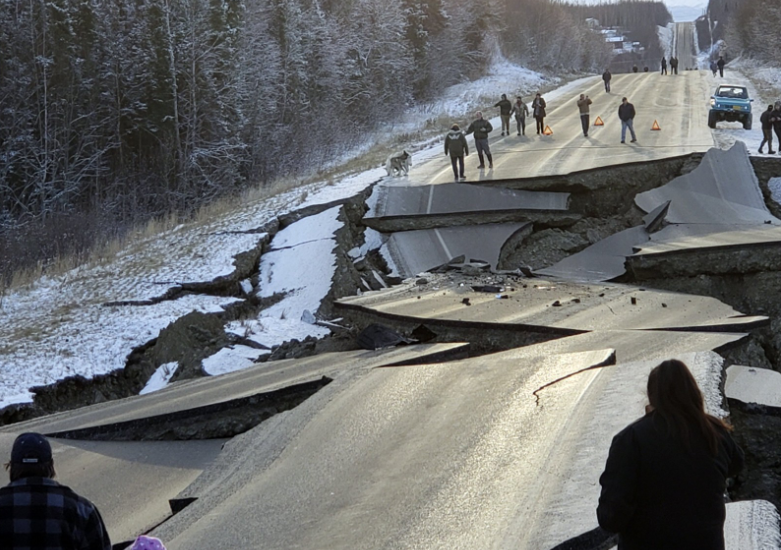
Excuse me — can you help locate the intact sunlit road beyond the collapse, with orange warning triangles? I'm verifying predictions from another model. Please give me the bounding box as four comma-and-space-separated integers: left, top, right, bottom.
406, 68, 714, 185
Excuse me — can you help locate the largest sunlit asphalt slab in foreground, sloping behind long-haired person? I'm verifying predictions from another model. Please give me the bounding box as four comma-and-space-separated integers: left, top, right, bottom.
152, 349, 779, 550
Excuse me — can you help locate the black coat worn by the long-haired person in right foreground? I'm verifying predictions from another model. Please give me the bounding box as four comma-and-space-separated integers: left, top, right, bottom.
597, 412, 743, 550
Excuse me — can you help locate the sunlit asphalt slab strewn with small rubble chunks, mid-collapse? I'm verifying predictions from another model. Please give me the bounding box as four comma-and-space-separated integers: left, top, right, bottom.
336, 277, 768, 336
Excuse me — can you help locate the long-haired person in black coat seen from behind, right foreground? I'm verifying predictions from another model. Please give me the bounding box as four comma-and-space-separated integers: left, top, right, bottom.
597, 359, 743, 550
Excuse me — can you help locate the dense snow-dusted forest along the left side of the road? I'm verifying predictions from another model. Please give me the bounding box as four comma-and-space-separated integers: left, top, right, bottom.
0, 0, 624, 275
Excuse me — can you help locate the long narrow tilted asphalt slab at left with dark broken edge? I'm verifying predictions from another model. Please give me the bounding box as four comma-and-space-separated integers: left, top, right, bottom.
0, 343, 469, 440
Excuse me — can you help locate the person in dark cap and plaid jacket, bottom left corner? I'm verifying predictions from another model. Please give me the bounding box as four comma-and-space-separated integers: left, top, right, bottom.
0, 433, 111, 550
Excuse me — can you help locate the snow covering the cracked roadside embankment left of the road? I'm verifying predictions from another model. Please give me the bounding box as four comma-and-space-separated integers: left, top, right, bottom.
0, 60, 558, 408
